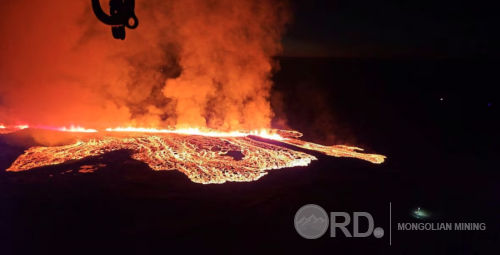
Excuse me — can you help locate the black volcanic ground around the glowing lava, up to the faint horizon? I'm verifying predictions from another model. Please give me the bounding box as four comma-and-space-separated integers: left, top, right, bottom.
0, 59, 500, 254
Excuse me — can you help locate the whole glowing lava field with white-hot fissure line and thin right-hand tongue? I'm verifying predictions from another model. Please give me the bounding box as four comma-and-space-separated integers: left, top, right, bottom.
7, 128, 385, 184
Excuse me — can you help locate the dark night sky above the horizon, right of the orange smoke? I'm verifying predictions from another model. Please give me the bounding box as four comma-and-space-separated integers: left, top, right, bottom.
284, 0, 500, 57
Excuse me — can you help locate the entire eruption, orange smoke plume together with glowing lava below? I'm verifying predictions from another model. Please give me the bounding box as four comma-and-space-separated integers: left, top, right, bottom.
0, 0, 384, 183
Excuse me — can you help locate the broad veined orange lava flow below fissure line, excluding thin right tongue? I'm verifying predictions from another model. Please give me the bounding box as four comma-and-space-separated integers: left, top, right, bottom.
7, 134, 316, 184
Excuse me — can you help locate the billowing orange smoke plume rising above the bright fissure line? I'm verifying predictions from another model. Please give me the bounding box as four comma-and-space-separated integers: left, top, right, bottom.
0, 0, 288, 130
